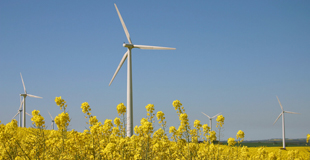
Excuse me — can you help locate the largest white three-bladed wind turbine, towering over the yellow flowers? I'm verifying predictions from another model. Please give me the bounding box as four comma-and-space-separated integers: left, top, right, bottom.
109, 3, 175, 137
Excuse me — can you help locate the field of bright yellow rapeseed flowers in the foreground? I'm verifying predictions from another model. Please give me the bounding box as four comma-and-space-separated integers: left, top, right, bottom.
0, 97, 310, 160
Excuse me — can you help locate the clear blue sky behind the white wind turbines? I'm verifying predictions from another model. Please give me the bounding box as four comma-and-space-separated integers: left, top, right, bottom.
0, 1, 310, 140
